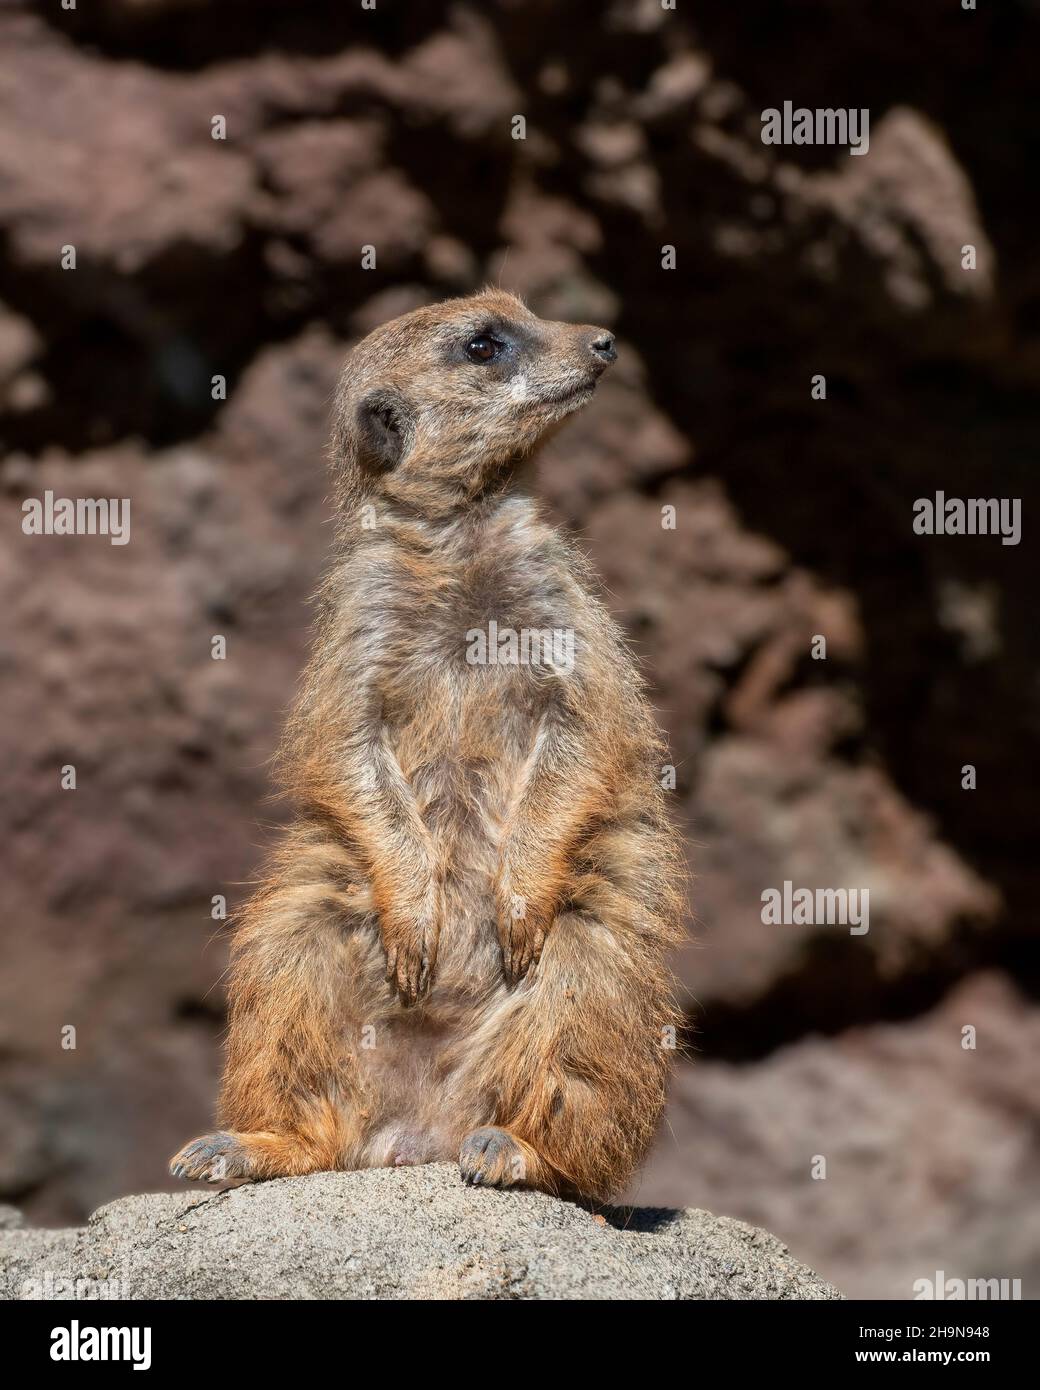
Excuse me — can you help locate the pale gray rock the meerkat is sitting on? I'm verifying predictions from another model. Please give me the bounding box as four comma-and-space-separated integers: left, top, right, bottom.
0, 1163, 841, 1300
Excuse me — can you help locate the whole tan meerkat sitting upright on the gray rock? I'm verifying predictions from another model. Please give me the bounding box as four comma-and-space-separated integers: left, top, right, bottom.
171, 289, 684, 1200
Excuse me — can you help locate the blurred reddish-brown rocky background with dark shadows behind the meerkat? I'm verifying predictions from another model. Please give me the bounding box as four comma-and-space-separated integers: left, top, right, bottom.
0, 0, 1040, 1298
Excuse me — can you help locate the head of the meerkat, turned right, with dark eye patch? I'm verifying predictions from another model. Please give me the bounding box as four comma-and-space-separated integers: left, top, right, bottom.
334, 289, 617, 516
